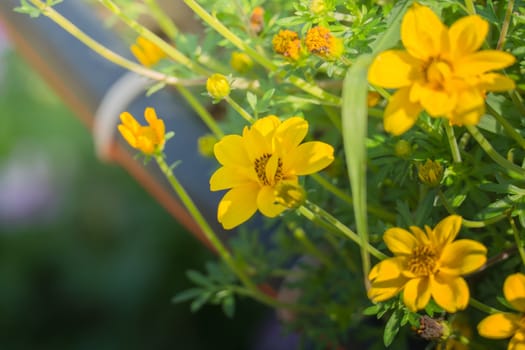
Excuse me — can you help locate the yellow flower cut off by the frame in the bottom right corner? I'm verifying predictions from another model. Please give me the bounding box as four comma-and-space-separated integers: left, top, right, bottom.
478, 273, 525, 350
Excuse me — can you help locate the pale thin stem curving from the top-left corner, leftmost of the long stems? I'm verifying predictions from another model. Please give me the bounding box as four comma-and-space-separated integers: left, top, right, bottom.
30, 0, 197, 85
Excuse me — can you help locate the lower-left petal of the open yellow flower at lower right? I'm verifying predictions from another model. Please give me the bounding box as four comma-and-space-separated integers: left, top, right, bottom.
368, 258, 407, 302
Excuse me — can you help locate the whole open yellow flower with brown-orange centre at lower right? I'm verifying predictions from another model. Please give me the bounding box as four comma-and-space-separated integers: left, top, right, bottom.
368, 215, 487, 312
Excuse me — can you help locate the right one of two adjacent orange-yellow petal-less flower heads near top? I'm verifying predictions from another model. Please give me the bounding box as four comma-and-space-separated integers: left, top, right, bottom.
304, 26, 343, 59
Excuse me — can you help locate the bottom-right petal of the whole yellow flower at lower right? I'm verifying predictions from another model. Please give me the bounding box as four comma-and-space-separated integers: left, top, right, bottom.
431, 273, 470, 313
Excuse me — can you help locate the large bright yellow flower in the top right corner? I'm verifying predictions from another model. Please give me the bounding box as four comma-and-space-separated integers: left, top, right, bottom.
368, 3, 515, 135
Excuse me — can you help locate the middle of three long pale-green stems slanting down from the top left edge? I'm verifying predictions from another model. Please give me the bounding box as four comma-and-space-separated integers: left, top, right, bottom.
99, 0, 212, 76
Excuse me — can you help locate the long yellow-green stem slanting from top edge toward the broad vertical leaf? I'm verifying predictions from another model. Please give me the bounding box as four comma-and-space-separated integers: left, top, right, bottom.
181, 0, 341, 106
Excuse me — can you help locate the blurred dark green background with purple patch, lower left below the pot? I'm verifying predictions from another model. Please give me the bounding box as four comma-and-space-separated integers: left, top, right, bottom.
0, 40, 266, 350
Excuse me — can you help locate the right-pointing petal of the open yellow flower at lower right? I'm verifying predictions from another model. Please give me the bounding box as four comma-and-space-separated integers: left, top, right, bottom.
440, 239, 487, 276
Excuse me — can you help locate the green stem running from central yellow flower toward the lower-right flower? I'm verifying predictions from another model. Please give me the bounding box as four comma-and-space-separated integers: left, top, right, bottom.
297, 201, 387, 260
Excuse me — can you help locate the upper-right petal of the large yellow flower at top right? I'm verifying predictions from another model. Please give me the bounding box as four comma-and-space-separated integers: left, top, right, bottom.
448, 15, 489, 60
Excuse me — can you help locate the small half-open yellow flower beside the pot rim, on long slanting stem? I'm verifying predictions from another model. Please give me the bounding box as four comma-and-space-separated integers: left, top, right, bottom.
118, 107, 166, 155
